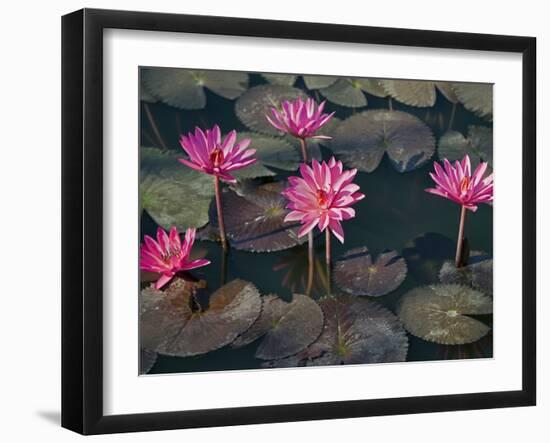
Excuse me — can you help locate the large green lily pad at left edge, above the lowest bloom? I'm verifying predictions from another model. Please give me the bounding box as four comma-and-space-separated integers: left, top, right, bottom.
139, 148, 214, 231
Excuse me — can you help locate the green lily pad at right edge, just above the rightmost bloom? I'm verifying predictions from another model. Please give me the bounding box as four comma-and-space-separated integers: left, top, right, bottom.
438, 125, 493, 168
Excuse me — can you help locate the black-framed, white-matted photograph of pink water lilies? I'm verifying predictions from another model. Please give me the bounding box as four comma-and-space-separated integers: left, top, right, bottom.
62, 9, 536, 434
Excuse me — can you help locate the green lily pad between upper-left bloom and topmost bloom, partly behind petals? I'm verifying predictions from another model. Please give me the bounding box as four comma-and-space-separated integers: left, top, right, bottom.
233, 132, 300, 179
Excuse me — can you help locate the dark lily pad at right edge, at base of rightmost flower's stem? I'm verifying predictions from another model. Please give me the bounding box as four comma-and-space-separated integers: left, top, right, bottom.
439, 251, 493, 296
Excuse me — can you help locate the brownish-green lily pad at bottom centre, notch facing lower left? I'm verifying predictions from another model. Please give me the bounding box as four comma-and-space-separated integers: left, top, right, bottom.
232, 294, 324, 360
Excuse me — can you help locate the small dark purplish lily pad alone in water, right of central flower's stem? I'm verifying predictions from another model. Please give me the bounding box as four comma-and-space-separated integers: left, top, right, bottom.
334, 247, 407, 297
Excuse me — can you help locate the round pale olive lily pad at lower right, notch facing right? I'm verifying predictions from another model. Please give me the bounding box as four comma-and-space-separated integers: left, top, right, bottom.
397, 284, 493, 345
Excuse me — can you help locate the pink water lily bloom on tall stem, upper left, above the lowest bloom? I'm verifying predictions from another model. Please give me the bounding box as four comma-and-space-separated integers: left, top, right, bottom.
179, 125, 256, 183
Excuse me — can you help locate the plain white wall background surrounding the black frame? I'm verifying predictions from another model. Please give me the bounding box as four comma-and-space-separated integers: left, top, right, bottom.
0, 0, 550, 443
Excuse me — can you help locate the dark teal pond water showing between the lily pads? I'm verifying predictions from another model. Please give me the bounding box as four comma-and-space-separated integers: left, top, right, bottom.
141, 74, 493, 373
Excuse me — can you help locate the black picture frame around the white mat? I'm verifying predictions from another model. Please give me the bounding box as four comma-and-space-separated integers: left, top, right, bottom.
62, 9, 536, 434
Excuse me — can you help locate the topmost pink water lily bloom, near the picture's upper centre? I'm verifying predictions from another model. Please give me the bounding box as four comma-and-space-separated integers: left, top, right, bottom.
266, 97, 334, 139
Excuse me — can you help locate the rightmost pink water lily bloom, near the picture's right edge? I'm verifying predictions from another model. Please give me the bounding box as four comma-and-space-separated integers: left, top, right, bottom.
426, 155, 493, 212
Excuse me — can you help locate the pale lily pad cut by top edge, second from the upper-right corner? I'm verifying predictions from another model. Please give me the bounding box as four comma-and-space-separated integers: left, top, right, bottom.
380, 80, 457, 107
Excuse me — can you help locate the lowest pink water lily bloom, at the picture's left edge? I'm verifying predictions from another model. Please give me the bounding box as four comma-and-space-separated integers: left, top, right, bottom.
140, 226, 210, 289
